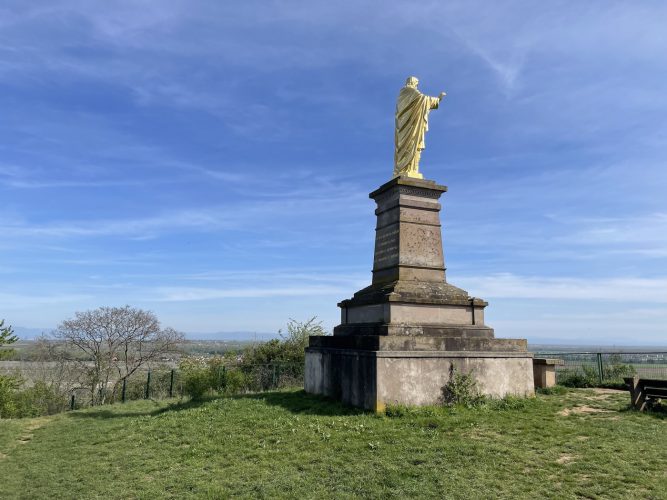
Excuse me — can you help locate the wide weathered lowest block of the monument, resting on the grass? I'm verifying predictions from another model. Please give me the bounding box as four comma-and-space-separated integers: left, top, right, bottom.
305, 347, 534, 412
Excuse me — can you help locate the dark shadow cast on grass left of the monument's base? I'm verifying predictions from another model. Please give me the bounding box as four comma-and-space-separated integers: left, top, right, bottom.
232, 390, 368, 416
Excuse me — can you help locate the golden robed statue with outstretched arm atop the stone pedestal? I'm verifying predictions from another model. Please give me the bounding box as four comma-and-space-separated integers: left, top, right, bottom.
394, 76, 447, 179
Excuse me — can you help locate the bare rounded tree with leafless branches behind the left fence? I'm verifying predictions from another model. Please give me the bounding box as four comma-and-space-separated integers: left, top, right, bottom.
54, 306, 184, 404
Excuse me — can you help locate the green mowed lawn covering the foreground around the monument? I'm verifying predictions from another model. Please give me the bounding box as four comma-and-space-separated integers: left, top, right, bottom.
0, 390, 667, 499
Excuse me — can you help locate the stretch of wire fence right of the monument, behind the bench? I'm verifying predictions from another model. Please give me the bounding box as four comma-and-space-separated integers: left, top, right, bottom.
535, 352, 667, 385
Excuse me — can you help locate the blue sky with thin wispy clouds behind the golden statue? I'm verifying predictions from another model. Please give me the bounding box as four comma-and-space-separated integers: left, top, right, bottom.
0, 0, 667, 345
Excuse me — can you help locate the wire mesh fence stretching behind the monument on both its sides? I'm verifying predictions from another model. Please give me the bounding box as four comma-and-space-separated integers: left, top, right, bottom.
5, 351, 667, 416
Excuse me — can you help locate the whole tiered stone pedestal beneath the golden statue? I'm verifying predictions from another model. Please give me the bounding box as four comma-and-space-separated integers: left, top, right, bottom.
305, 177, 534, 411
